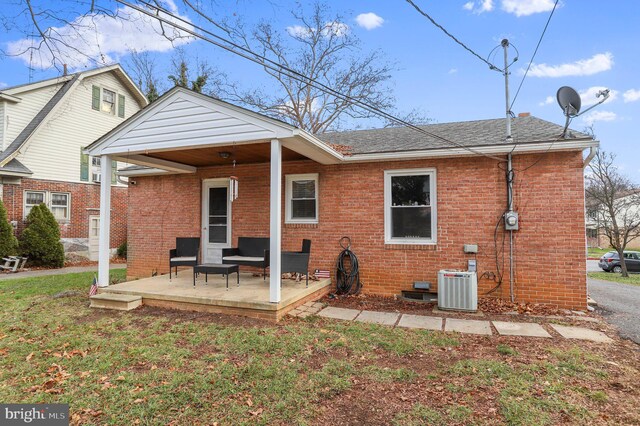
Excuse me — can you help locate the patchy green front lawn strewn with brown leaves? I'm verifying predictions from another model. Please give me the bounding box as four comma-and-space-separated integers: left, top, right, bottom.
0, 271, 640, 425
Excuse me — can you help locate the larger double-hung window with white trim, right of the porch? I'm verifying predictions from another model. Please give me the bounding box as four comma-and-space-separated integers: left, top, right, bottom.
384, 169, 437, 244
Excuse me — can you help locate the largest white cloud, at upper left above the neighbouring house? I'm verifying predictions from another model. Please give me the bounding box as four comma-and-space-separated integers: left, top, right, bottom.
7, 0, 195, 69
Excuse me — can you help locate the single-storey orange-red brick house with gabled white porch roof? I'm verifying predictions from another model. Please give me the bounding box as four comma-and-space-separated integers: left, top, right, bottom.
87, 88, 598, 309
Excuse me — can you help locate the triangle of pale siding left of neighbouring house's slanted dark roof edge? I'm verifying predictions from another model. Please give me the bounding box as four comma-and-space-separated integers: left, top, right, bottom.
4, 84, 62, 148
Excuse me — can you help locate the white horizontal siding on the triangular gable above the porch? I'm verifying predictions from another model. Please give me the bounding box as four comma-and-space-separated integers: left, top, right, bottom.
110, 97, 276, 151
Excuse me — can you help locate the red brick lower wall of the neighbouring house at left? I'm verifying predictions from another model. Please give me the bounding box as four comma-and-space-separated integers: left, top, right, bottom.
2, 179, 128, 248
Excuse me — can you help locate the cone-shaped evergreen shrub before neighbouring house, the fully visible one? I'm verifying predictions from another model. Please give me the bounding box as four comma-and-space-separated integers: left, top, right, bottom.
20, 204, 64, 268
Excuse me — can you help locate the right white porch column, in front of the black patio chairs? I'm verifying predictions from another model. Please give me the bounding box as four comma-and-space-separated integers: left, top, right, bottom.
269, 139, 282, 303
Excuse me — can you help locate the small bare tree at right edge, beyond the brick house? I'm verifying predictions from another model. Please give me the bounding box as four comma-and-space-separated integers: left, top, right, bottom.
586, 151, 640, 277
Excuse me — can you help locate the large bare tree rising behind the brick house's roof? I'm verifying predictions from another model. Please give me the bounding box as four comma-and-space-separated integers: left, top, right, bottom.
220, 2, 410, 133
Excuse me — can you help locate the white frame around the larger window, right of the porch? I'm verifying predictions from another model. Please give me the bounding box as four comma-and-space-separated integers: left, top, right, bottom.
384, 168, 438, 245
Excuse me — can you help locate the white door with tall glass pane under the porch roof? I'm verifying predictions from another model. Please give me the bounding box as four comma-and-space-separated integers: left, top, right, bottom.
202, 179, 231, 263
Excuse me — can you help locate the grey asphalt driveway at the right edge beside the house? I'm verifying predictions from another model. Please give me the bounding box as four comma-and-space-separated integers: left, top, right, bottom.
587, 278, 640, 344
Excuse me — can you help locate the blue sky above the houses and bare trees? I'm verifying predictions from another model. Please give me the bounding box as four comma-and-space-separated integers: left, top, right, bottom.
0, 0, 640, 182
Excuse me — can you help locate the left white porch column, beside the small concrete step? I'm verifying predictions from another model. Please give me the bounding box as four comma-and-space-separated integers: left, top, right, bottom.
98, 155, 111, 287
